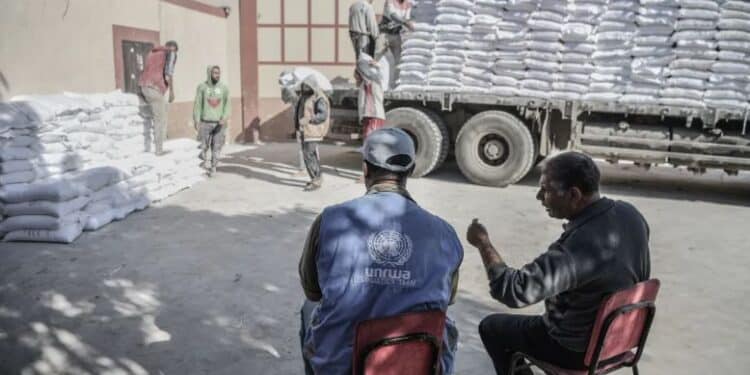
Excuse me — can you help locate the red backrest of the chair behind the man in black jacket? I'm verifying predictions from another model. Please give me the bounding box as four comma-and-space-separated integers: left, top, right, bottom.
584, 279, 659, 368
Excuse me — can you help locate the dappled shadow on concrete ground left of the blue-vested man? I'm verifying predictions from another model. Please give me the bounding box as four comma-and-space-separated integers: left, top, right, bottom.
0, 206, 316, 374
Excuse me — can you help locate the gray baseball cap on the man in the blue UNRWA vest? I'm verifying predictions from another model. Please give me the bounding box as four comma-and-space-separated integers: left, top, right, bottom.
361, 128, 416, 172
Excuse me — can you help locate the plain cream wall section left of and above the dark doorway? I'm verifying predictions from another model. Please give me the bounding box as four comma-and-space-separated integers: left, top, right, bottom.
0, 0, 160, 99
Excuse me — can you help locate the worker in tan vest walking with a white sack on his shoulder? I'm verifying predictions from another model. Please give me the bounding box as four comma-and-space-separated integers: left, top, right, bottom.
294, 76, 331, 191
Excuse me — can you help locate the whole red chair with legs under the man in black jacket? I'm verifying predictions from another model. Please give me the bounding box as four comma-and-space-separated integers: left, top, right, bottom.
510, 279, 660, 375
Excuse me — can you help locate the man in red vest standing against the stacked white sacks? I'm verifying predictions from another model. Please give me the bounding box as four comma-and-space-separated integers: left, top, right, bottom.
138, 40, 178, 155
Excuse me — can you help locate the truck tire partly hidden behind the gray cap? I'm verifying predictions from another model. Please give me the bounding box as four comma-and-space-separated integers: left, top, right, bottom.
385, 107, 450, 177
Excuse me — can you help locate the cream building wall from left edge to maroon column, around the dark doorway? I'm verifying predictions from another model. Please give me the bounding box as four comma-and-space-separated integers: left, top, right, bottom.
0, 0, 242, 140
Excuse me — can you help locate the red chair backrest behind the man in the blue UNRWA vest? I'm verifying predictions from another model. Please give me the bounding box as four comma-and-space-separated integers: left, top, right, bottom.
352, 310, 445, 375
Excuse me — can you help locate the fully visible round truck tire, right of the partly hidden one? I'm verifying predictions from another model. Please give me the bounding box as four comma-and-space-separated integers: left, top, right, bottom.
456, 111, 537, 186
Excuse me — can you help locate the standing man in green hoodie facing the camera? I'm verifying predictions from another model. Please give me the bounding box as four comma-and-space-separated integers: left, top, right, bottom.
193, 65, 231, 175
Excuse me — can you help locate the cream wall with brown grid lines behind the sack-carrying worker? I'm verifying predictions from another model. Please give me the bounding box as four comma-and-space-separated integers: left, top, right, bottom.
258, 0, 384, 139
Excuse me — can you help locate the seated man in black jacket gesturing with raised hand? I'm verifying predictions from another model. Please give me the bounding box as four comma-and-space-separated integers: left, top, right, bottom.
467, 152, 650, 374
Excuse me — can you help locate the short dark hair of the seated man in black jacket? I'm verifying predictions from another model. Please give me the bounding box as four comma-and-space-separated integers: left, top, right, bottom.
543, 151, 601, 195
